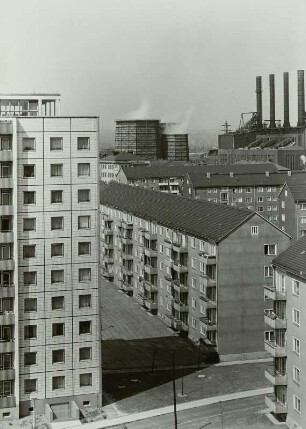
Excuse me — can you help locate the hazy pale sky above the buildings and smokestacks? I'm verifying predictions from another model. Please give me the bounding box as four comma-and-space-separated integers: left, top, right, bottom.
0, 0, 306, 129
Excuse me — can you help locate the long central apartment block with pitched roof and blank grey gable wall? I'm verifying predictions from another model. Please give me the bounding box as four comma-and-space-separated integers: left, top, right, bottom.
100, 182, 290, 360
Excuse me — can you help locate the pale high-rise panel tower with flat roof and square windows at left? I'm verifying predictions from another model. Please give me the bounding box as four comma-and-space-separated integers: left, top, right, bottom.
0, 94, 101, 420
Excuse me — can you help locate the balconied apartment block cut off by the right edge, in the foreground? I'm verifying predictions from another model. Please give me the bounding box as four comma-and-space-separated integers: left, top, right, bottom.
265, 237, 306, 429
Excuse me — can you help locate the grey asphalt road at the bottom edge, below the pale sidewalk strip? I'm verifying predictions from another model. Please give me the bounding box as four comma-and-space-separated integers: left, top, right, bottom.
108, 395, 286, 429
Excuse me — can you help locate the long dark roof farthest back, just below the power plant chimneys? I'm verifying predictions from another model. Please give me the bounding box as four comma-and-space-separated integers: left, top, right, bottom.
122, 162, 290, 180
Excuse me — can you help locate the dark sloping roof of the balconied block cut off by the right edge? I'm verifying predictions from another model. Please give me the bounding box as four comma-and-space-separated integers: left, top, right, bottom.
273, 236, 306, 279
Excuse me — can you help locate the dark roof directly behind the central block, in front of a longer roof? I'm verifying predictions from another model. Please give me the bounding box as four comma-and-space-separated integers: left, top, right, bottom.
188, 172, 289, 188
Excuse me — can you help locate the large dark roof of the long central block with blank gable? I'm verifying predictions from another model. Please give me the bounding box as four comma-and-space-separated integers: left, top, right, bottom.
100, 182, 255, 242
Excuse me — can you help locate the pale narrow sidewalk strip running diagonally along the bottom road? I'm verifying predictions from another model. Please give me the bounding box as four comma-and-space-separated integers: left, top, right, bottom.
65, 387, 272, 429
